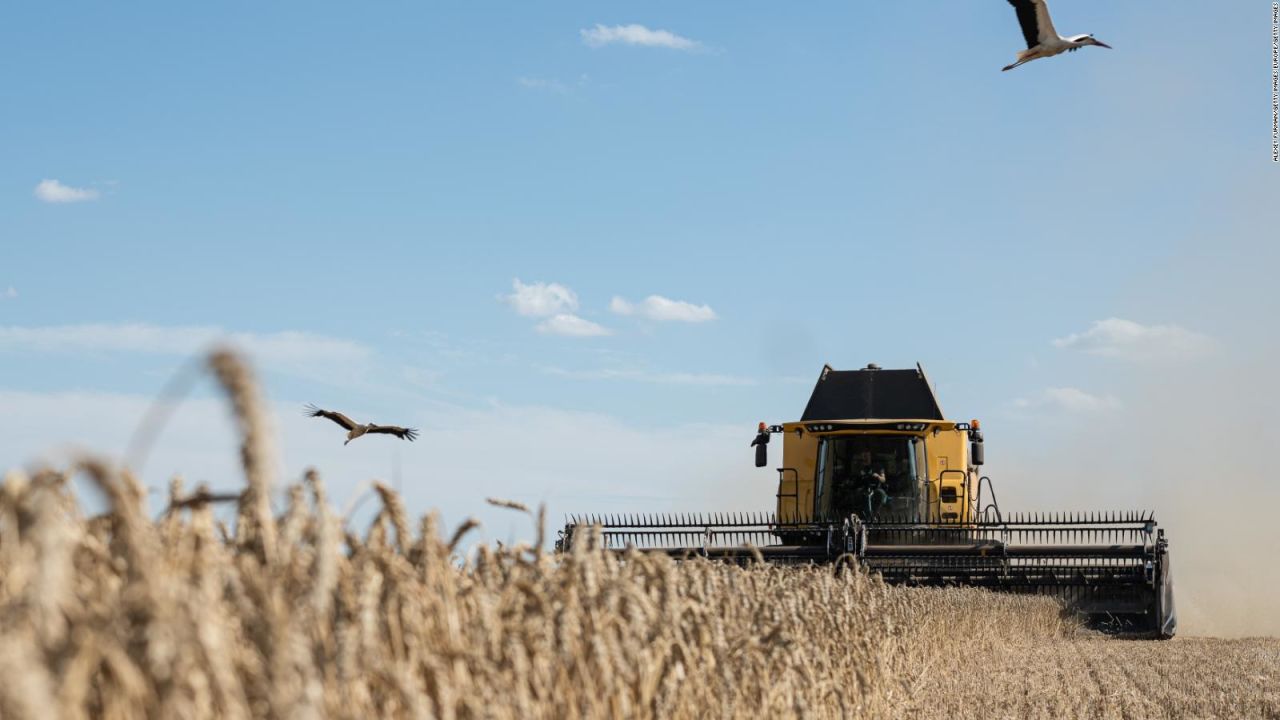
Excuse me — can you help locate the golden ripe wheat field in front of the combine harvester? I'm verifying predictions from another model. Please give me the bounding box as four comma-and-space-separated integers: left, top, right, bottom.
0, 352, 1280, 719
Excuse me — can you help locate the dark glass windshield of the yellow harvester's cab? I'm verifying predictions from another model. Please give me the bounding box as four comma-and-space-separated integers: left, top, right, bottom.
818, 434, 925, 520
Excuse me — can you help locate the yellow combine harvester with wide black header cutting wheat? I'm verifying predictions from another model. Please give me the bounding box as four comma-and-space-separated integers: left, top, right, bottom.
557, 365, 1176, 638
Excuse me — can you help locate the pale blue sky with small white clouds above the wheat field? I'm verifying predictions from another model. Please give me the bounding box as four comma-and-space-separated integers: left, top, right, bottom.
0, 0, 1280, 602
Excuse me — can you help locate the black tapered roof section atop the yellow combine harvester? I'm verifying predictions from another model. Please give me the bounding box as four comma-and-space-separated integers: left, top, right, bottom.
800, 365, 943, 421
